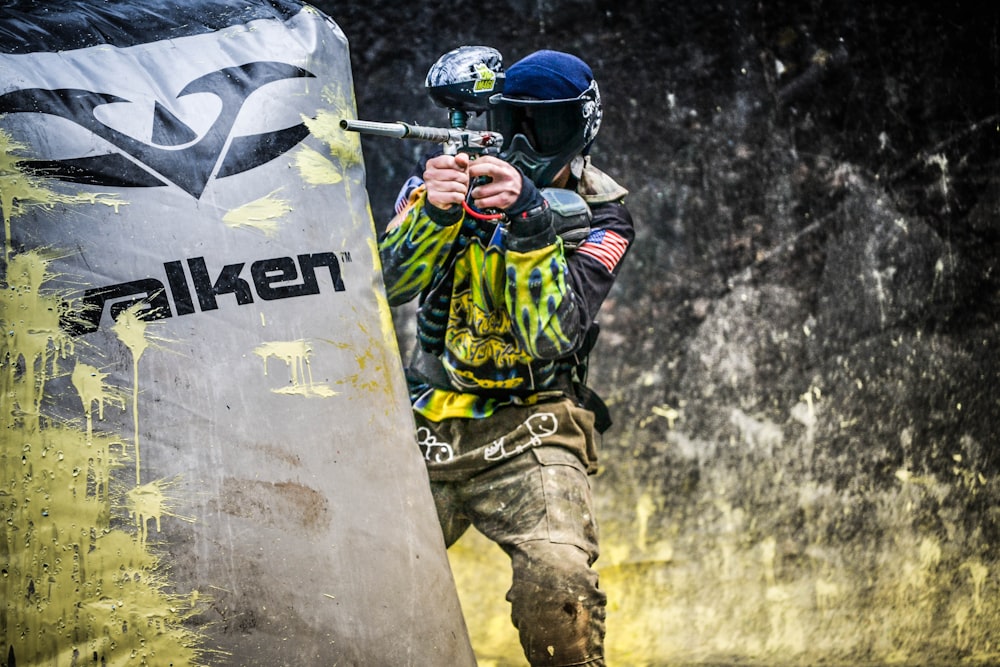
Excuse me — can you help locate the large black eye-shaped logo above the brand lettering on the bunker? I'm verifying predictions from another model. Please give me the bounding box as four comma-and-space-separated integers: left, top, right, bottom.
0, 62, 314, 199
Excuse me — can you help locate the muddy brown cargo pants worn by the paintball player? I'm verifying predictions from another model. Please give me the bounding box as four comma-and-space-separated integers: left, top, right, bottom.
417, 402, 607, 667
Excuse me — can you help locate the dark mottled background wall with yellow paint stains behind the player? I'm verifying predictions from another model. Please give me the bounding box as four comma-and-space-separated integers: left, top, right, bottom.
316, 0, 1000, 665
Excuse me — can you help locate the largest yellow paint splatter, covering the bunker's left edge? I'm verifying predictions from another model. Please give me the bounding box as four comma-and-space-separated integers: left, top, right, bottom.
0, 131, 206, 665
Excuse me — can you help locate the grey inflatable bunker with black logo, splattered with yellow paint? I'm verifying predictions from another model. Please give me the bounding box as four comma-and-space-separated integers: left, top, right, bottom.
0, 0, 474, 667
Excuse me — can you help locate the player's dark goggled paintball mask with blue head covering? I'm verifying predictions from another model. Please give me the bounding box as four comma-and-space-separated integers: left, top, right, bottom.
489, 51, 601, 187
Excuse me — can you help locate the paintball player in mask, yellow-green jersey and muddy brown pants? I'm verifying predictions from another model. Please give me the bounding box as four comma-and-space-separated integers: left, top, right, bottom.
379, 50, 635, 665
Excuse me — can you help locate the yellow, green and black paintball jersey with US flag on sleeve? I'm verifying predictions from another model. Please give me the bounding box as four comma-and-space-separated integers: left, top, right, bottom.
379, 159, 634, 421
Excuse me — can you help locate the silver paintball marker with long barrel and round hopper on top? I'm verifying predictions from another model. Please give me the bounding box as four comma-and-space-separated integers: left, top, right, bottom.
340, 46, 504, 155
